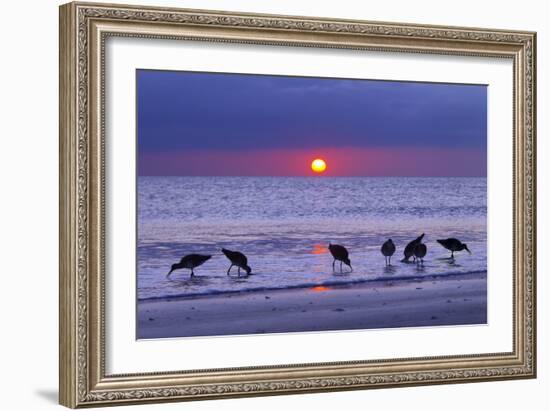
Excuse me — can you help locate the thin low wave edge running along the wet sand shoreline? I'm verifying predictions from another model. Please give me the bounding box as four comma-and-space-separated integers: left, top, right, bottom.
138, 270, 487, 301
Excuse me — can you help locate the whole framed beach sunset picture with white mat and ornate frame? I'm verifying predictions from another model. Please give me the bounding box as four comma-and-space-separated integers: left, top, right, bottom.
59, 3, 537, 407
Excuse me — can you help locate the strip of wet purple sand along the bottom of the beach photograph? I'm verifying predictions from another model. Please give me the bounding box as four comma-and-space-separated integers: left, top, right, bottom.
138, 273, 487, 339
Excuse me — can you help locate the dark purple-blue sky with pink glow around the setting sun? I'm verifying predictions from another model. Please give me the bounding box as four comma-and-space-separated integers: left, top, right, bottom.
136, 70, 487, 177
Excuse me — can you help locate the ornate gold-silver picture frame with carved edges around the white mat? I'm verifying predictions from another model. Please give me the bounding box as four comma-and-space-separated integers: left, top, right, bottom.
59, 3, 536, 408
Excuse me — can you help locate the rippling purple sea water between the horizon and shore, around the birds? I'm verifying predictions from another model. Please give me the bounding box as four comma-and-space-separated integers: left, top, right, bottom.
137, 176, 487, 300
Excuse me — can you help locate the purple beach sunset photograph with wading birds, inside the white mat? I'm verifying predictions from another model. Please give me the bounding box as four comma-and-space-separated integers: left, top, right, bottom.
136, 69, 487, 339
